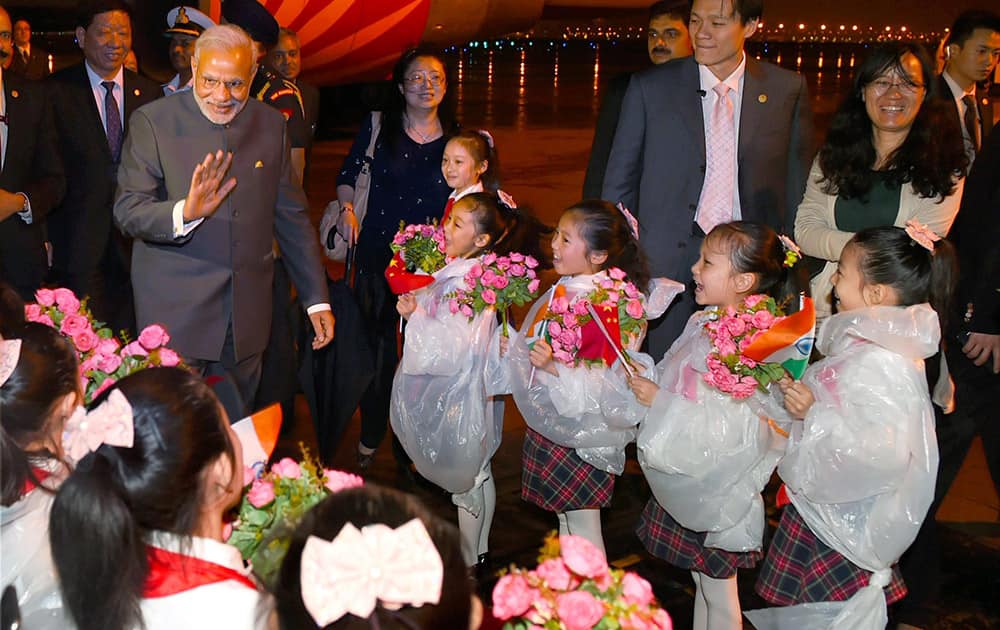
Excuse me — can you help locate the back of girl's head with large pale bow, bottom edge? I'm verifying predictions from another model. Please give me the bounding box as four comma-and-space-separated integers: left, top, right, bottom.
274, 484, 483, 630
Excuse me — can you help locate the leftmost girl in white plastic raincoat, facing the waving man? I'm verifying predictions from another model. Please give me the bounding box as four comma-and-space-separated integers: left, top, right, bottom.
389, 193, 541, 567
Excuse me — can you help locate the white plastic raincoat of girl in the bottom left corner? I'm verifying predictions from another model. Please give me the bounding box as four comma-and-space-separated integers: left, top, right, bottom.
0, 466, 73, 630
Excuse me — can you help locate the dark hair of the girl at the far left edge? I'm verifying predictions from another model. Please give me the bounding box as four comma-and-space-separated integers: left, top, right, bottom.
0, 322, 80, 505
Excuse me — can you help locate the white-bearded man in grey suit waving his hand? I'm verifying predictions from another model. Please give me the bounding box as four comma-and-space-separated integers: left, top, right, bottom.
115, 24, 334, 412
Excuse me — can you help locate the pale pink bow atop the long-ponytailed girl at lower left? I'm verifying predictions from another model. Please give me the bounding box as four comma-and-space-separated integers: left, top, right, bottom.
63, 389, 135, 462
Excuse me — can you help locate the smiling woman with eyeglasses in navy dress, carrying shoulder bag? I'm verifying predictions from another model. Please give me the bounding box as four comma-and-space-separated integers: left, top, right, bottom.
337, 49, 455, 472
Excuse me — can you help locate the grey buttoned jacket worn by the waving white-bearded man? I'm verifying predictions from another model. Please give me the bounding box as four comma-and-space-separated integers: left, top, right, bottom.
115, 90, 329, 361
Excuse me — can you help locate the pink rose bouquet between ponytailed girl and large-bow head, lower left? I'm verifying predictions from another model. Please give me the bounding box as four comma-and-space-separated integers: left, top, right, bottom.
226, 447, 364, 584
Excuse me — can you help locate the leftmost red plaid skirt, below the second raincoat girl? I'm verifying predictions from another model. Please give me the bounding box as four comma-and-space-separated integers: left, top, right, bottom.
521, 427, 615, 512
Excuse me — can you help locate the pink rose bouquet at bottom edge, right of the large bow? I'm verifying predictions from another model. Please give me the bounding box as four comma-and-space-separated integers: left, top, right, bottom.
493, 534, 673, 630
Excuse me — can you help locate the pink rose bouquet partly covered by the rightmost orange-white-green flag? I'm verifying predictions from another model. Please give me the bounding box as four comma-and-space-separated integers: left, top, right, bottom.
702, 294, 785, 400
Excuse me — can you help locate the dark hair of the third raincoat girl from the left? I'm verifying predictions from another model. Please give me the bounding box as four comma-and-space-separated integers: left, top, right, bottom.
705, 221, 809, 313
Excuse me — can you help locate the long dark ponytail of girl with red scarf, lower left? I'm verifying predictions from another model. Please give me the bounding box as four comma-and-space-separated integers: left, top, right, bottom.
49, 446, 147, 630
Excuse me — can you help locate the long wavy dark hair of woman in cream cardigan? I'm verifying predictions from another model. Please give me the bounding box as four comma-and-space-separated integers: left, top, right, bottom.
819, 42, 968, 199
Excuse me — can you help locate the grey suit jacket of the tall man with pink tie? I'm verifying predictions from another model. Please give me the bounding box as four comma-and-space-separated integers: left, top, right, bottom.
601, 56, 813, 357
